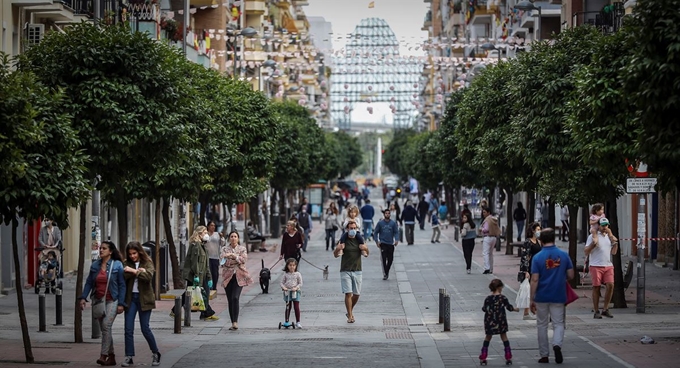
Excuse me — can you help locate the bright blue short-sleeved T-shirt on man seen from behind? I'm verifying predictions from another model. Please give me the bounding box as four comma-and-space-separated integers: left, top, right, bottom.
531, 246, 574, 303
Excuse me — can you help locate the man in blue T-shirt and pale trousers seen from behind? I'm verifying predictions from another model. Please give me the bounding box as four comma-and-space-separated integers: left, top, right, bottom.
531, 228, 574, 364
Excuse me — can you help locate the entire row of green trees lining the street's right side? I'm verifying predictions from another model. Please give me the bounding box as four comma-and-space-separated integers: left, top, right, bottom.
394, 0, 680, 308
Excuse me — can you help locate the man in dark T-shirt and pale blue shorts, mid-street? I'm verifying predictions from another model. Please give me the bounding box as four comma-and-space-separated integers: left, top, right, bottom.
333, 220, 368, 323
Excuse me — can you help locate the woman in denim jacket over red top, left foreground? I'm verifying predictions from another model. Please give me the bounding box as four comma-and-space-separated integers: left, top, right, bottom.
80, 241, 126, 365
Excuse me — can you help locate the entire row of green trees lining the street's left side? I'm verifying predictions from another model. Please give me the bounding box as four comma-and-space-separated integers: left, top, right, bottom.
0, 23, 361, 363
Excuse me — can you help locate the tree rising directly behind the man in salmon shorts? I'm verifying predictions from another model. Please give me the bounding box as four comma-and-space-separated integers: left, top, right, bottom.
566, 28, 642, 307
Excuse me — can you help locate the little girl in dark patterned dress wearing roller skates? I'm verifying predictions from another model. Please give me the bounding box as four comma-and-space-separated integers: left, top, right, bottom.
479, 279, 519, 365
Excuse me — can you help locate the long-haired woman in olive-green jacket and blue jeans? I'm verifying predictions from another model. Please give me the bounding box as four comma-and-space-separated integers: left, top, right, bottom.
121, 242, 161, 367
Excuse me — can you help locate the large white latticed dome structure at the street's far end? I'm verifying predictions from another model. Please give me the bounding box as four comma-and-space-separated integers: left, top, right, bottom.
330, 18, 422, 130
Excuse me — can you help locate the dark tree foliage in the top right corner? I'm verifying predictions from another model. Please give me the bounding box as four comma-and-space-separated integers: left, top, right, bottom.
621, 0, 680, 187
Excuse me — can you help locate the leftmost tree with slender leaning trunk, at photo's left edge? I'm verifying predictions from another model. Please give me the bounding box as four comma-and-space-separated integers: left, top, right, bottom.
0, 55, 88, 363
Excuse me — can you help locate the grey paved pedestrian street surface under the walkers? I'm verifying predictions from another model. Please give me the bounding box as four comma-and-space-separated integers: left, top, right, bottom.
0, 190, 680, 368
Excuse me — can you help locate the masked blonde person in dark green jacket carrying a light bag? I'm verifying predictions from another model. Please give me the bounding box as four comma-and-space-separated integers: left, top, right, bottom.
175, 226, 220, 321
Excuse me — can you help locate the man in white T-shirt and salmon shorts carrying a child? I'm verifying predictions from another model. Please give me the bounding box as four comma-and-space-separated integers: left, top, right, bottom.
585, 217, 619, 319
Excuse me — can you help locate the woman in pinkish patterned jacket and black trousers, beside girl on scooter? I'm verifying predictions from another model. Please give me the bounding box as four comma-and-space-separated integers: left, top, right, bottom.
220, 231, 253, 331
